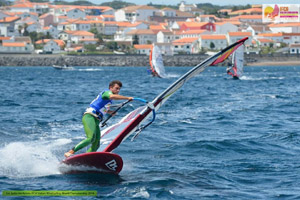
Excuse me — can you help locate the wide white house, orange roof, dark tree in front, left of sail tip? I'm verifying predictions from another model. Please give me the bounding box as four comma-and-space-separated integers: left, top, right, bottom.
199, 34, 228, 50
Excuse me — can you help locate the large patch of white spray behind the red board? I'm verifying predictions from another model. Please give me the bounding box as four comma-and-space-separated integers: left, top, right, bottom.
0, 139, 71, 178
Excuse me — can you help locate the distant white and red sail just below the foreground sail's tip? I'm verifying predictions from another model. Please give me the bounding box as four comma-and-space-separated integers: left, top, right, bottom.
227, 46, 244, 78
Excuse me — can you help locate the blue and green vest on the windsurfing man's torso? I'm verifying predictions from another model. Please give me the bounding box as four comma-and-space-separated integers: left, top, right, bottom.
84, 90, 113, 121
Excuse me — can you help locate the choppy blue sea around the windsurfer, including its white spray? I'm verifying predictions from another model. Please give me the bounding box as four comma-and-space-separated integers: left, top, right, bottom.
0, 66, 300, 200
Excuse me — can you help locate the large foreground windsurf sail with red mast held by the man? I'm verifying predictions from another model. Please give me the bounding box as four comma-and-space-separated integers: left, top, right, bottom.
100, 37, 248, 152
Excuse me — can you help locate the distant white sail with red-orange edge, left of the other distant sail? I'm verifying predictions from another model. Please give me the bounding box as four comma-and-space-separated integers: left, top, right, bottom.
149, 45, 166, 78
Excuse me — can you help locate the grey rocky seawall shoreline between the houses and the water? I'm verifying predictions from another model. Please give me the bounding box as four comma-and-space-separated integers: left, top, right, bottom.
0, 54, 300, 67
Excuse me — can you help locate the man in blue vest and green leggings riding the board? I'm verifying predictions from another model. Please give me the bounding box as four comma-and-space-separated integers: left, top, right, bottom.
65, 80, 133, 157
